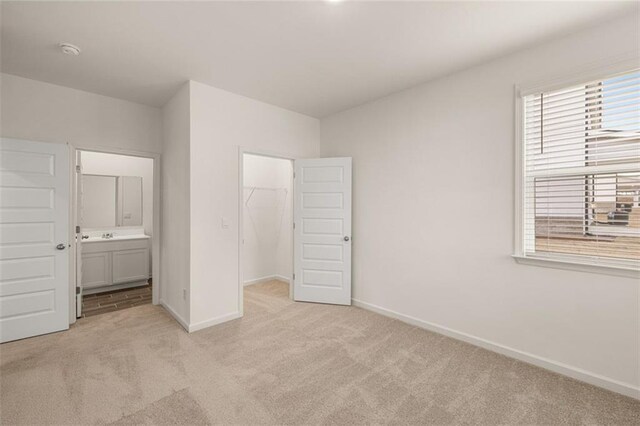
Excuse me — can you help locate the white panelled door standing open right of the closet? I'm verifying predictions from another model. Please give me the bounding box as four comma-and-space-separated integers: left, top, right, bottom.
293, 158, 351, 305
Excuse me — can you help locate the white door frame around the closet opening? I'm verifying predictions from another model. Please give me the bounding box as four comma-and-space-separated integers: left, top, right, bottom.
238, 146, 296, 316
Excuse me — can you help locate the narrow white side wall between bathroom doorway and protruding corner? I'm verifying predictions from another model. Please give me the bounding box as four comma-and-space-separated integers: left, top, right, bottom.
160, 84, 190, 328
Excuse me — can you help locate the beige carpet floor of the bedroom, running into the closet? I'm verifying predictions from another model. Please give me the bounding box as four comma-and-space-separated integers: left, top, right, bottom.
0, 282, 640, 425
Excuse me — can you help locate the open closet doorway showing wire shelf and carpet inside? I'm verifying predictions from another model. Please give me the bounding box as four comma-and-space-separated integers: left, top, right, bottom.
240, 151, 293, 309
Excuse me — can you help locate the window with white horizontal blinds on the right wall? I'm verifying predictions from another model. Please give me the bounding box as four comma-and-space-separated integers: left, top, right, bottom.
521, 71, 640, 269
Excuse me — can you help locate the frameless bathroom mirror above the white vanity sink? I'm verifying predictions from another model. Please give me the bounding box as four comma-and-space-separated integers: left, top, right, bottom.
82, 174, 142, 229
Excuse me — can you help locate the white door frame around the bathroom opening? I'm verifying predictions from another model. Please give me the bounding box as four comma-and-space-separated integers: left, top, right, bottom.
69, 145, 162, 324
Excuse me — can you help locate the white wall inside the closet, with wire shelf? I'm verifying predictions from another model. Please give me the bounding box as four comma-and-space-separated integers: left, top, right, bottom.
242, 154, 293, 283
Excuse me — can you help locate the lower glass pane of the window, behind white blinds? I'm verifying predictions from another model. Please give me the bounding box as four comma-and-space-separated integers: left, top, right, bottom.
535, 173, 640, 260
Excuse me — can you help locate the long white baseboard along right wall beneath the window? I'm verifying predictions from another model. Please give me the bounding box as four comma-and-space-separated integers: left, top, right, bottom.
352, 299, 640, 400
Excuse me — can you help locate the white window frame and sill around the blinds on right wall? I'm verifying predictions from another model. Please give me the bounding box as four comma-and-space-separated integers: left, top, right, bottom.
512, 52, 640, 279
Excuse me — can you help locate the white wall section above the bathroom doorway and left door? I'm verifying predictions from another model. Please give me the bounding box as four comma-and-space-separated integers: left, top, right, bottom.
0, 74, 162, 153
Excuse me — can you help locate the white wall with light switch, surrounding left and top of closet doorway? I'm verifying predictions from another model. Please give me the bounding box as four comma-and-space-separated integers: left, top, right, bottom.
190, 81, 319, 329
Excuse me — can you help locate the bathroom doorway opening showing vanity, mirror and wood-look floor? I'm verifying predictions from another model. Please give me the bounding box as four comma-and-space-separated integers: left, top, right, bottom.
74, 150, 159, 318
